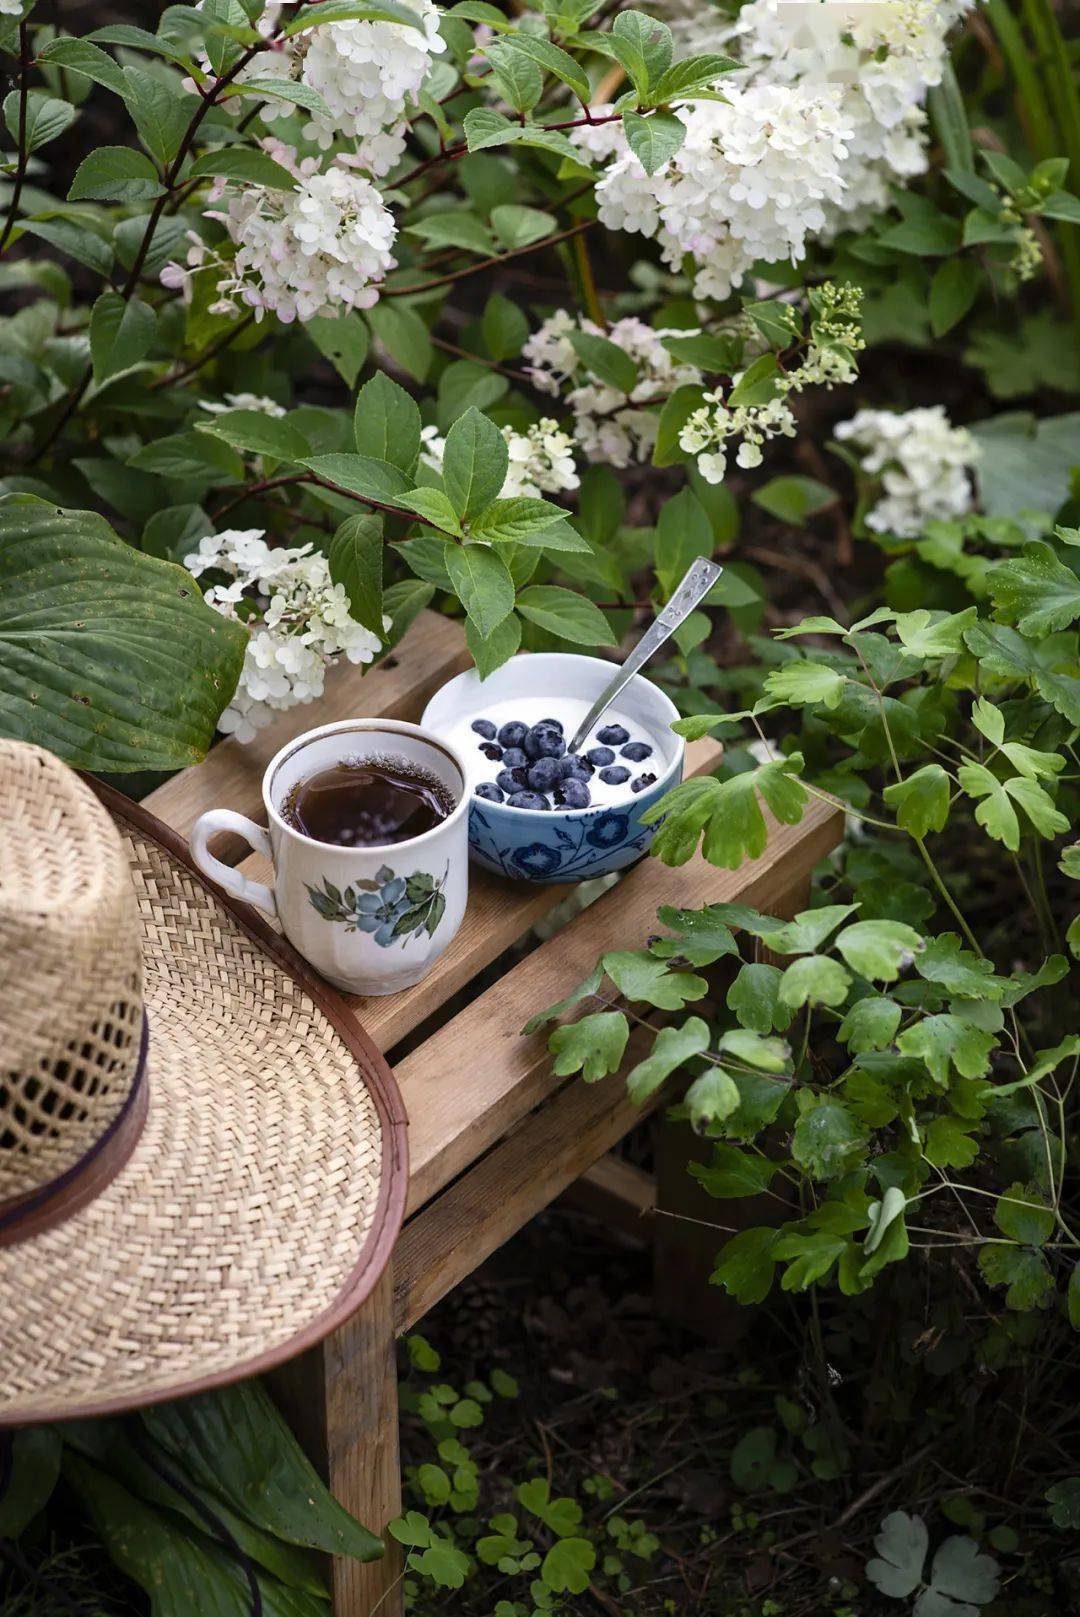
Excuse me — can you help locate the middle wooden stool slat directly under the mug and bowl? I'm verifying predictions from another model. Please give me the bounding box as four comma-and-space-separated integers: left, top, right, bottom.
232, 736, 724, 1049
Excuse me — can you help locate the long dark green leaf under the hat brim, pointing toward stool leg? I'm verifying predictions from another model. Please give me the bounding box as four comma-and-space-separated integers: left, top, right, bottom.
142, 1381, 383, 1560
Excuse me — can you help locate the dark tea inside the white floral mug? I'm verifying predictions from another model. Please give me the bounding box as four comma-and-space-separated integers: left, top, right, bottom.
285, 757, 454, 847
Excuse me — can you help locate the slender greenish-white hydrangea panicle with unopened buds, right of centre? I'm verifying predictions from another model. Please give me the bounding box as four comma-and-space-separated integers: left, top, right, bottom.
679, 281, 867, 483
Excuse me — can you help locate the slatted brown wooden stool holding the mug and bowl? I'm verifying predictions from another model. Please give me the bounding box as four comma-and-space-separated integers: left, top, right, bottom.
146, 611, 842, 1617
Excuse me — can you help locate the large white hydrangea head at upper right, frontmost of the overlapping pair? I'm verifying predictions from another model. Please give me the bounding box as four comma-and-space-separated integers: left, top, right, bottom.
597, 82, 854, 299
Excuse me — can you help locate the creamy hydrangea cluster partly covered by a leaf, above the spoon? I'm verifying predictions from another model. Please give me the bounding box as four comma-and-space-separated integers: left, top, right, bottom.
522, 309, 702, 467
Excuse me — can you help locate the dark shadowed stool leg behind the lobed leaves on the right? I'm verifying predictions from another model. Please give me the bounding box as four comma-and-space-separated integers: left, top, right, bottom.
653, 872, 810, 1347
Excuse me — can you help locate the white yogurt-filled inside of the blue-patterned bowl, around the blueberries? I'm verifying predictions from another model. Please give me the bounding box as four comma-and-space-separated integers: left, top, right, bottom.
422, 652, 684, 818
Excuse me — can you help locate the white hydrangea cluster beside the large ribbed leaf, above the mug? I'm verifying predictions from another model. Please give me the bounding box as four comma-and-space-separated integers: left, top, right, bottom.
184, 529, 382, 741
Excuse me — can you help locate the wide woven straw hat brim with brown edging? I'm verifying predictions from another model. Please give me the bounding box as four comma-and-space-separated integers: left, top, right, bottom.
0, 781, 409, 1426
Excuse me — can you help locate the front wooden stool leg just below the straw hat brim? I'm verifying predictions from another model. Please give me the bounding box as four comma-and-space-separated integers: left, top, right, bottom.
268, 1264, 404, 1617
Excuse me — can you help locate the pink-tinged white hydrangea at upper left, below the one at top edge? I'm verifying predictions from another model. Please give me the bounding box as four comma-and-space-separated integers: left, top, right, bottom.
205, 146, 398, 323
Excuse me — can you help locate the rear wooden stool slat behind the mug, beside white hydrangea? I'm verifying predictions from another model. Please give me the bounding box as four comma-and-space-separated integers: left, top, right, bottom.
144, 611, 470, 865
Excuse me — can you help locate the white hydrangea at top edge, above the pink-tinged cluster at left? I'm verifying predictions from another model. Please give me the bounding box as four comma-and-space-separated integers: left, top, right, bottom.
299, 0, 446, 175
